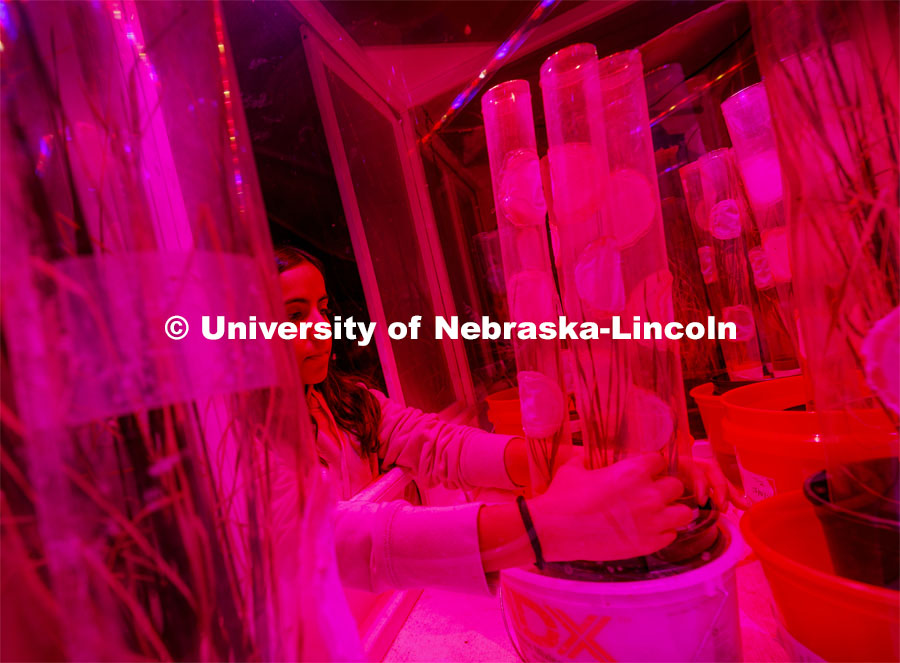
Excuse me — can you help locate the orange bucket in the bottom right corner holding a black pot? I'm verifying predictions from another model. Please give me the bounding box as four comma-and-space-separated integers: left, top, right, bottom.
741, 491, 900, 661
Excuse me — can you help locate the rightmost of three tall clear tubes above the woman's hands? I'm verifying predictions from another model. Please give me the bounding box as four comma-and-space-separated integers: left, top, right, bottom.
600, 50, 690, 478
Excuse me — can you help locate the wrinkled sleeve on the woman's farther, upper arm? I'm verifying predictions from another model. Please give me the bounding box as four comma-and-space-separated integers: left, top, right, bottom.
372, 389, 517, 490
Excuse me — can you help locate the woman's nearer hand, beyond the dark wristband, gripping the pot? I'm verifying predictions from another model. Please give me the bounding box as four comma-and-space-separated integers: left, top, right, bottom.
528, 454, 693, 562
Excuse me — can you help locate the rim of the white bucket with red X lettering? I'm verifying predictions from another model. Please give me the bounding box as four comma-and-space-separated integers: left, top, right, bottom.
500, 518, 747, 596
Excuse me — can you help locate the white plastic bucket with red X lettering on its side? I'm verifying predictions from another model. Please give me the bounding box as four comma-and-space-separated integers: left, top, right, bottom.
500, 518, 744, 661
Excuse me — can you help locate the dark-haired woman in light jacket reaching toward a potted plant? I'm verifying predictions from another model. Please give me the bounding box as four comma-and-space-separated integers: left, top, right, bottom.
276, 248, 724, 593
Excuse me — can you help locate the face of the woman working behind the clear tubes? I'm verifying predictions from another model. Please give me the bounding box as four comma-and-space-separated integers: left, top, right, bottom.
279, 263, 331, 385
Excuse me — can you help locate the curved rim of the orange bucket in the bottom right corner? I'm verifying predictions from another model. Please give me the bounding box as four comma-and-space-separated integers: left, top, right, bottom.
741, 489, 900, 607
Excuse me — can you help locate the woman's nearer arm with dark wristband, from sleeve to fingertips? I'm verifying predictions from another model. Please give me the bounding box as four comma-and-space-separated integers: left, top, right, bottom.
335, 455, 693, 594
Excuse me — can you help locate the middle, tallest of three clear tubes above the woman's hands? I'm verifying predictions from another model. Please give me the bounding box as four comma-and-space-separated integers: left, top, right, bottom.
541, 44, 627, 467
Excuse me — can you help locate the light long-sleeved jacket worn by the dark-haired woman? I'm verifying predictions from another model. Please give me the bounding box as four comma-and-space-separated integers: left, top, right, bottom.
276, 389, 516, 594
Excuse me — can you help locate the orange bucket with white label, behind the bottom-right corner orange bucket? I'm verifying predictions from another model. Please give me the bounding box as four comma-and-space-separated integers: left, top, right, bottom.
722, 376, 895, 501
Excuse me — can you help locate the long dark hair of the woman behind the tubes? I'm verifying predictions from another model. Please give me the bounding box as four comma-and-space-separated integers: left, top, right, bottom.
275, 246, 381, 455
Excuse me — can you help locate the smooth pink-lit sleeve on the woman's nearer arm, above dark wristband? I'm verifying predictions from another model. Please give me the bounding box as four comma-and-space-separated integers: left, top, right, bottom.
335, 501, 498, 595
